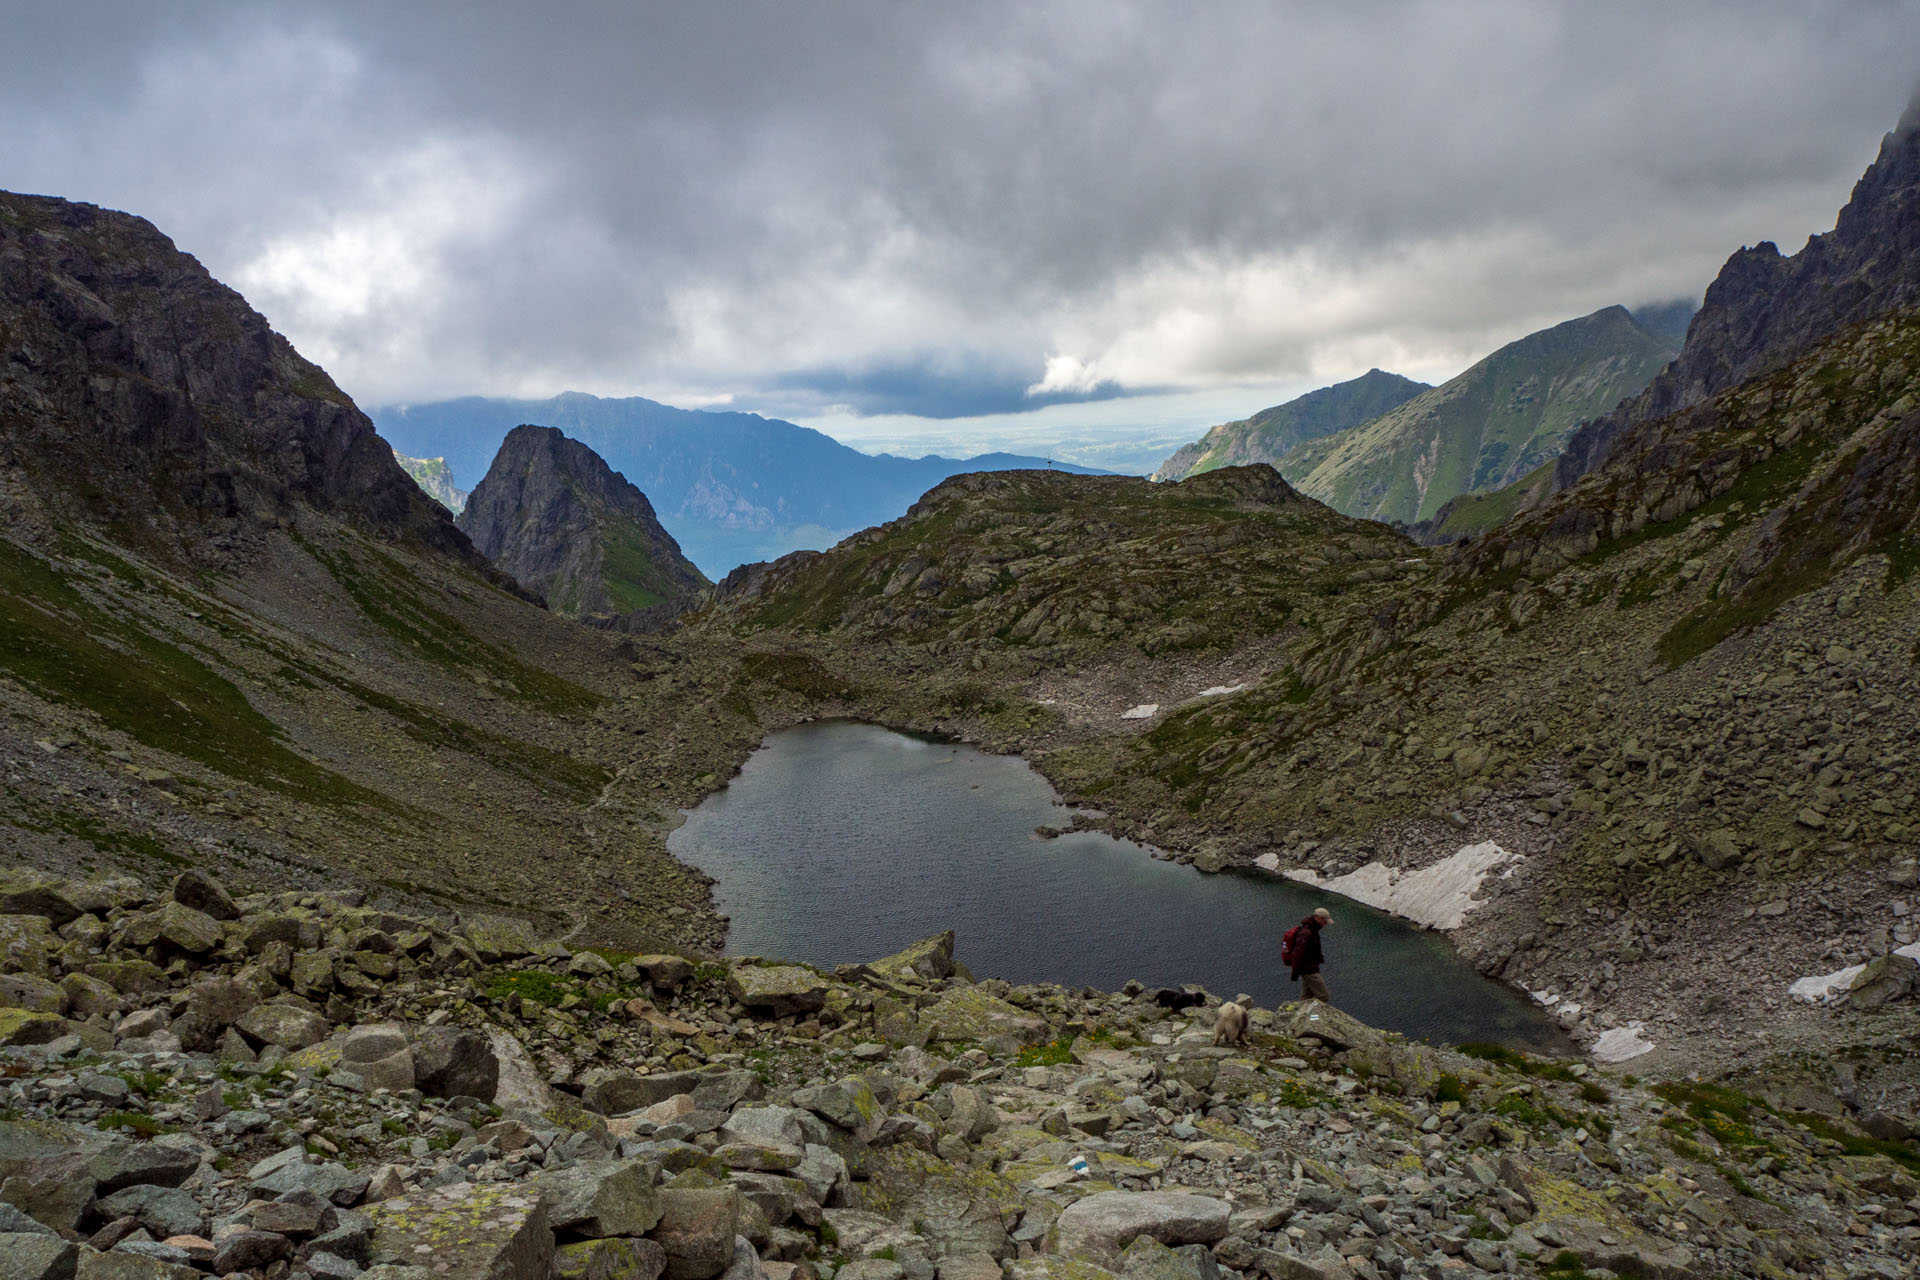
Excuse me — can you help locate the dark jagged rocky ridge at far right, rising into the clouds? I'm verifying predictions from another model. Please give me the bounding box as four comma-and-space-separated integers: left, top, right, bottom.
1553, 98, 1920, 489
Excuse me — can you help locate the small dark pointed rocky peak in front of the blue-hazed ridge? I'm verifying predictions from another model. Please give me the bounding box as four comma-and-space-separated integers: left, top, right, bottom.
457, 426, 708, 618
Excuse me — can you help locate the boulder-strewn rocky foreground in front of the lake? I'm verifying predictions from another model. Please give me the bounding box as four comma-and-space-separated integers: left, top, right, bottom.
0, 871, 1920, 1280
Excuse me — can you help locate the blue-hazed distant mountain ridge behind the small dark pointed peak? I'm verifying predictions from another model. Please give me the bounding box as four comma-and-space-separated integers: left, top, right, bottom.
372, 391, 1098, 578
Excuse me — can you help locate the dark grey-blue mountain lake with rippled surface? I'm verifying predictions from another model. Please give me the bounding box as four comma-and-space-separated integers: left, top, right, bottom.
666, 722, 1571, 1054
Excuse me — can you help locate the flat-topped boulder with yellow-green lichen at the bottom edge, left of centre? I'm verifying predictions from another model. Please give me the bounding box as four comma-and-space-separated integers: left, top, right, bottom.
365, 1182, 553, 1280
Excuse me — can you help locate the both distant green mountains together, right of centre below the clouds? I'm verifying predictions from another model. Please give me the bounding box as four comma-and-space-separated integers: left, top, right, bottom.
1154, 305, 1684, 524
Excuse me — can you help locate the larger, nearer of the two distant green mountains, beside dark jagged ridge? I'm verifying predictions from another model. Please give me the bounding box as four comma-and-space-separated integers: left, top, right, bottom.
1279, 307, 1674, 524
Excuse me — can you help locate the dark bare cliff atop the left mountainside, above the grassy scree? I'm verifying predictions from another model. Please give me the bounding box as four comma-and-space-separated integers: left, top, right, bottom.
0, 194, 478, 566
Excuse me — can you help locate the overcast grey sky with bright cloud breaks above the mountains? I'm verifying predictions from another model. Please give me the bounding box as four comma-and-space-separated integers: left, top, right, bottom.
0, 0, 1920, 450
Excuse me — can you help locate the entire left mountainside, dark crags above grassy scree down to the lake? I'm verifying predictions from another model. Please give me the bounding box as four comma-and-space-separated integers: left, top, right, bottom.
0, 196, 751, 940
